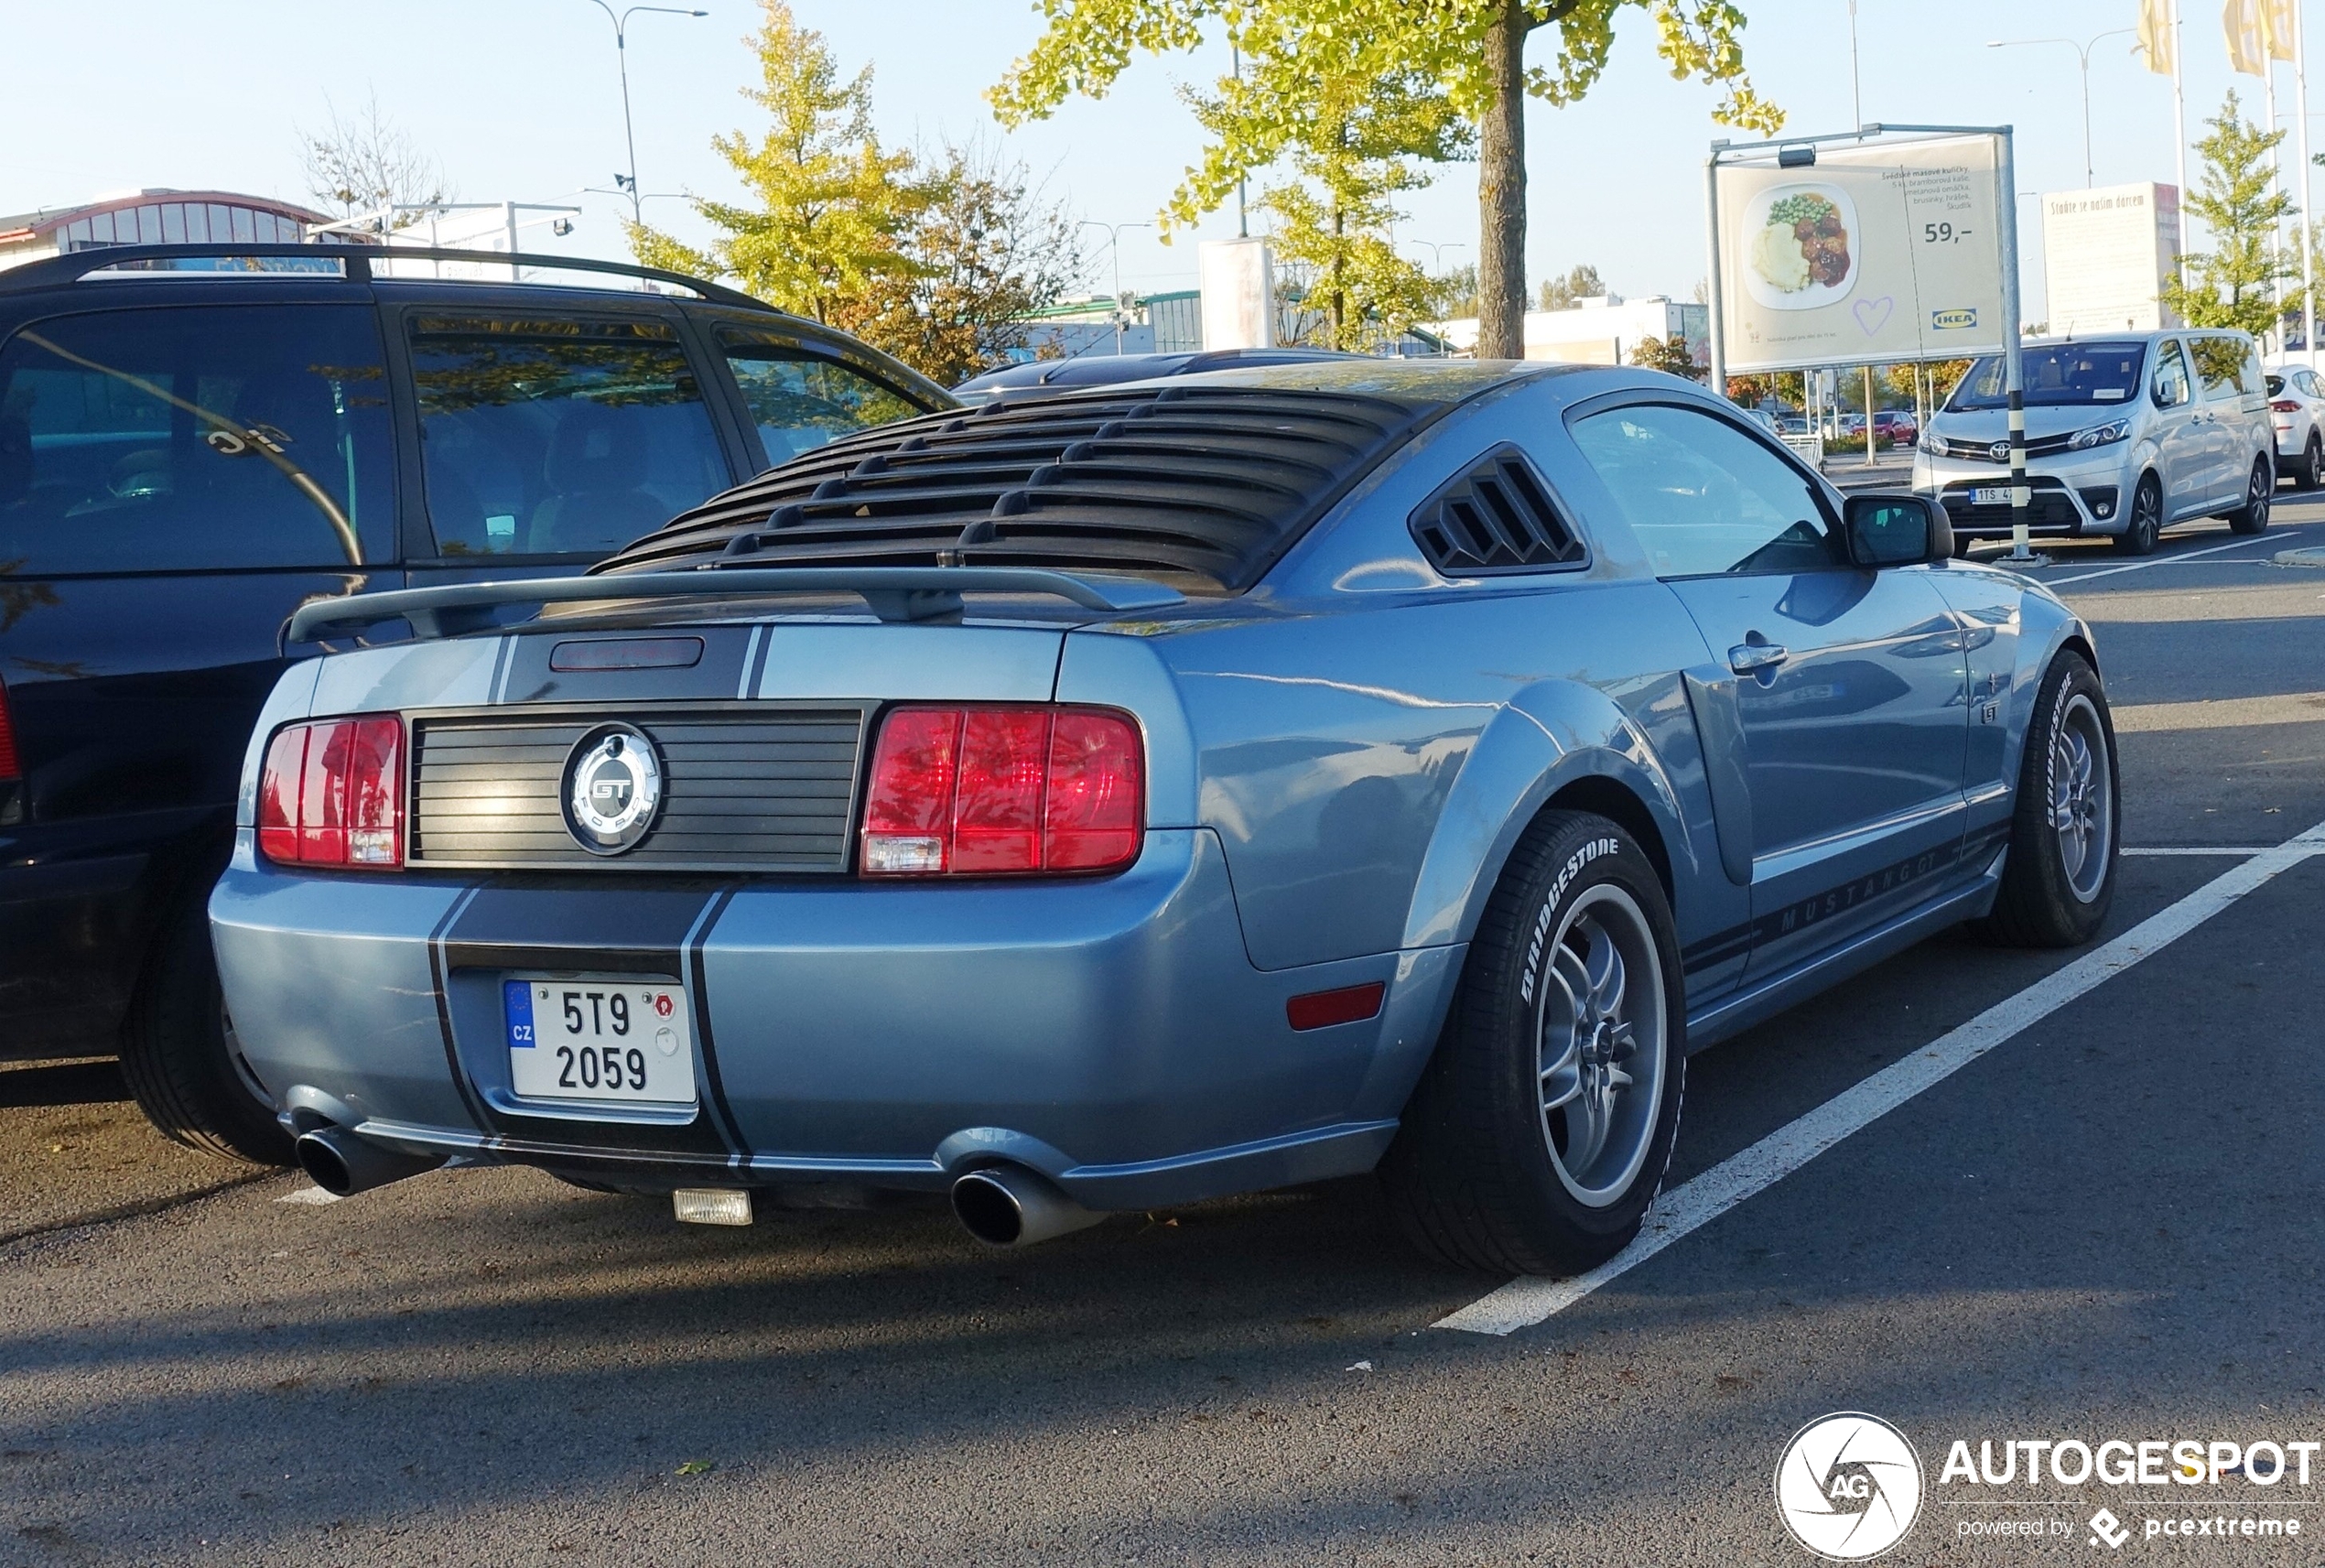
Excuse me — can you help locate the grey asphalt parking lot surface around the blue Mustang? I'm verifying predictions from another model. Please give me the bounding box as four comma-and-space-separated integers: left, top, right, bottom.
0, 495, 2325, 1568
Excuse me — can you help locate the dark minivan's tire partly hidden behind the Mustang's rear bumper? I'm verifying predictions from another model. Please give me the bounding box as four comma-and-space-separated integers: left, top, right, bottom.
121, 907, 297, 1165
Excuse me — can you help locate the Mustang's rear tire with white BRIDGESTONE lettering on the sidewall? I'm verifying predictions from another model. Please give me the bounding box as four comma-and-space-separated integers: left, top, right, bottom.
1381, 812, 1688, 1275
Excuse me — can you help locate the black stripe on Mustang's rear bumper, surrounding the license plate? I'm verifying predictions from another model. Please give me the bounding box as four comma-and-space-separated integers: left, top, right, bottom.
438, 877, 735, 1165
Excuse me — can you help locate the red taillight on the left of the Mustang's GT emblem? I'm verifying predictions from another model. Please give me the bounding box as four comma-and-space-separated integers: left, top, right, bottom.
258, 714, 405, 871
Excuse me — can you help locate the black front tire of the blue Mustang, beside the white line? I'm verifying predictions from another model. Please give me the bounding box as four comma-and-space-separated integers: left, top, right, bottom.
1984, 652, 2123, 946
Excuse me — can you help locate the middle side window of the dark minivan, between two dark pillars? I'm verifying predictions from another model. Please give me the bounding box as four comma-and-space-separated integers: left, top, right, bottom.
409, 317, 730, 556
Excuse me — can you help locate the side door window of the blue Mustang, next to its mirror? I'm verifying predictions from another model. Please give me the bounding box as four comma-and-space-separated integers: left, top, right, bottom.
1574, 403, 1839, 577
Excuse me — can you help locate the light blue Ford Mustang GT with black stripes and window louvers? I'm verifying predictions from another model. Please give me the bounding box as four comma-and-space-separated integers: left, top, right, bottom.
211, 362, 2120, 1272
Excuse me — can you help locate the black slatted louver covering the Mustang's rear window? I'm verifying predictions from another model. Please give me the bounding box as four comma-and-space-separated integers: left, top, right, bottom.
598, 386, 1437, 591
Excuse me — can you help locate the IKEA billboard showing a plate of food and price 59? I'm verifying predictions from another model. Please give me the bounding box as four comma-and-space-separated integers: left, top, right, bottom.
1714, 135, 2006, 374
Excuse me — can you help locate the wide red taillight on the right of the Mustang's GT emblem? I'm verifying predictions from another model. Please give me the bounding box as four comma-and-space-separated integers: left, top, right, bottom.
862, 708, 1146, 877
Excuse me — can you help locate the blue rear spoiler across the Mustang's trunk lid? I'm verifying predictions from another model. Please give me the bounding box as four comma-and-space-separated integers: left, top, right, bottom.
284, 566, 1185, 644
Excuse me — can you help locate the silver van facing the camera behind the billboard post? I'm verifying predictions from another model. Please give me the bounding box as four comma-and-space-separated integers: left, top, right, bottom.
1913, 330, 2276, 556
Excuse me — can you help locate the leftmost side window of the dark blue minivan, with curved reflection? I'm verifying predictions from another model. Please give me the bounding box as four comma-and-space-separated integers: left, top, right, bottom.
0, 305, 395, 577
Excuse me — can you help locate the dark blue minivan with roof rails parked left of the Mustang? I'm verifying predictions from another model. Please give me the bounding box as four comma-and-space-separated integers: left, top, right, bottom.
0, 244, 953, 1161
